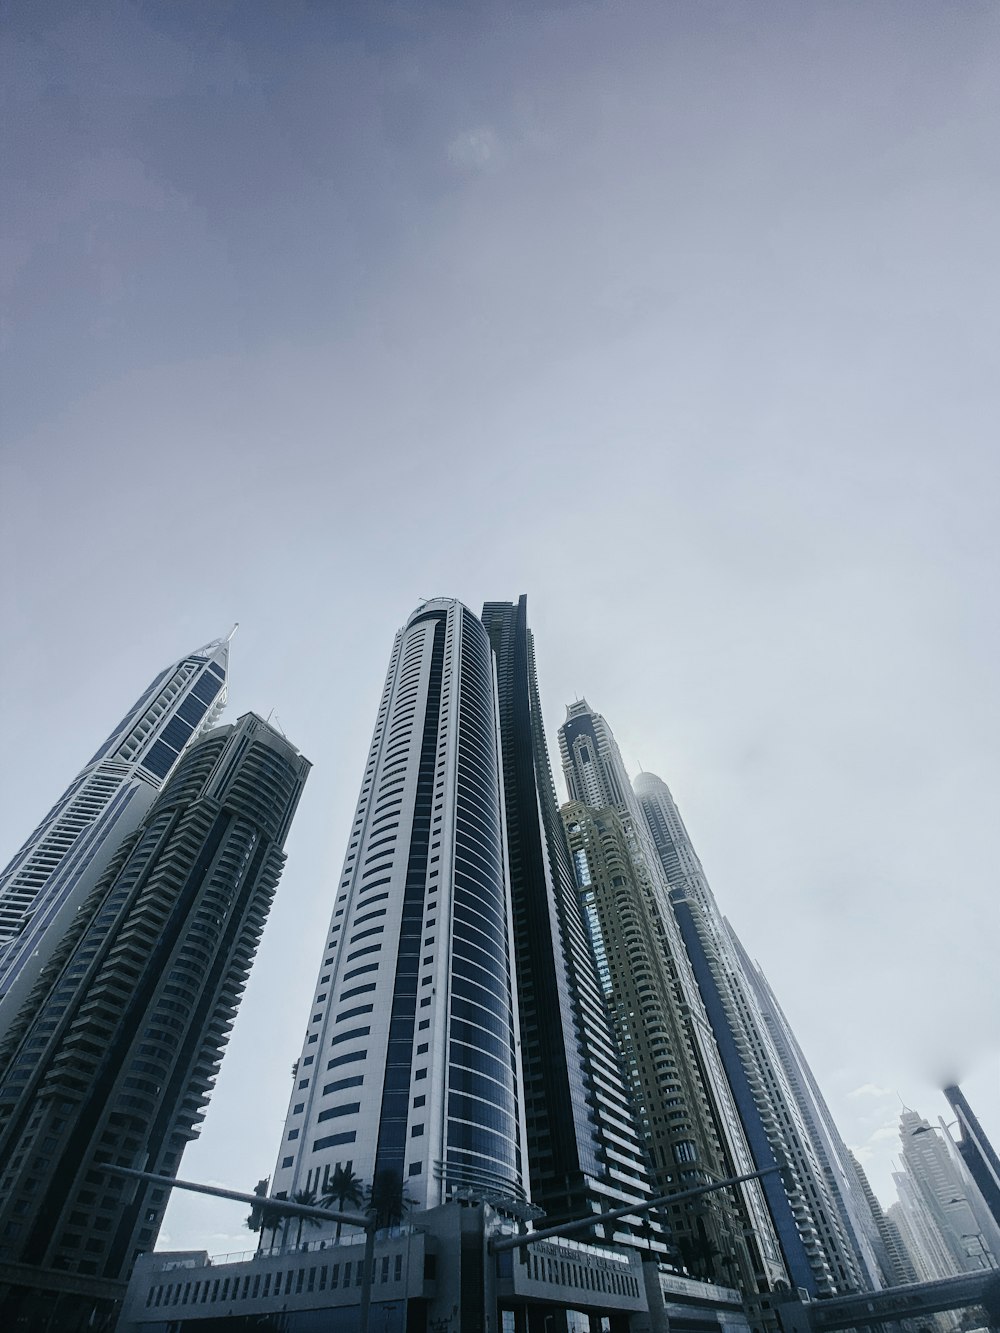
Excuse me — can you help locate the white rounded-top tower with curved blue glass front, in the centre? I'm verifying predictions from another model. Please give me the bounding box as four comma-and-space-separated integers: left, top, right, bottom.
272, 599, 527, 1208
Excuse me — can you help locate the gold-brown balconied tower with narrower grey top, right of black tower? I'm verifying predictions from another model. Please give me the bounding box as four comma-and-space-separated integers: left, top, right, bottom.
559, 700, 787, 1300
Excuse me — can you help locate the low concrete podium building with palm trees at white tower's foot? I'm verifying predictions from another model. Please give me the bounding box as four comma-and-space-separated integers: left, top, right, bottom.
119, 1204, 748, 1333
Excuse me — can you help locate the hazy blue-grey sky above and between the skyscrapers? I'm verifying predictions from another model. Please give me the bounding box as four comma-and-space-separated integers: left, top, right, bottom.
0, 0, 1000, 1253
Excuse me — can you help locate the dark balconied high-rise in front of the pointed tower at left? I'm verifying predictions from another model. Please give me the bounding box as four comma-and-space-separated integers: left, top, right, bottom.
0, 714, 309, 1333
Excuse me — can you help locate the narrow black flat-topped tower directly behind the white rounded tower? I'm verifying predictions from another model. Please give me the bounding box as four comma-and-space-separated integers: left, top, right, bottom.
483, 597, 663, 1249
